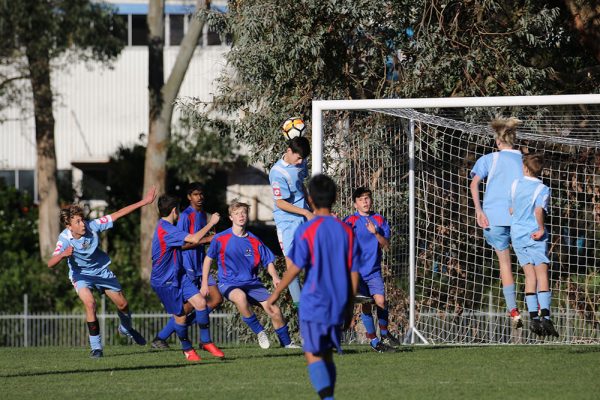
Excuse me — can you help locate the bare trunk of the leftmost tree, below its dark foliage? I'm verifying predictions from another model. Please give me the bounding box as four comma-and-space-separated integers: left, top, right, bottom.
27, 49, 60, 258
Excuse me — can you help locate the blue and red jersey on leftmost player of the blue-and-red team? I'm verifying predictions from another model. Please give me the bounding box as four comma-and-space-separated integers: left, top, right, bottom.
150, 218, 188, 287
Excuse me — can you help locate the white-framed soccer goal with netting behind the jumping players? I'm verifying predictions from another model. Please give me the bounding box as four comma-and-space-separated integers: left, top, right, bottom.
312, 95, 600, 344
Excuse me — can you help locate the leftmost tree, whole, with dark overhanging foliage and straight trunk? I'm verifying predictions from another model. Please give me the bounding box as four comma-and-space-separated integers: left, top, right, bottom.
0, 0, 125, 257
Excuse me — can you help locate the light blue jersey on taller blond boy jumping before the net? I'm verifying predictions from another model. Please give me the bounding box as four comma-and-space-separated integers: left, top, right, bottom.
471, 150, 523, 226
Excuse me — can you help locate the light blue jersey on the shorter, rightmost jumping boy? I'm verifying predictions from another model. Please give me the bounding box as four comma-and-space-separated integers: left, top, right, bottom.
510, 176, 550, 248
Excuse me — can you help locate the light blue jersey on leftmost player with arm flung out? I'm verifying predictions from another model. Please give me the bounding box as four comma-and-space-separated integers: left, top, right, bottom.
53, 215, 114, 282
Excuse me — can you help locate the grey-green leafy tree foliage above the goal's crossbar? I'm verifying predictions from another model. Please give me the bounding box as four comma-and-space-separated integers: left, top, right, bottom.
182, 0, 600, 165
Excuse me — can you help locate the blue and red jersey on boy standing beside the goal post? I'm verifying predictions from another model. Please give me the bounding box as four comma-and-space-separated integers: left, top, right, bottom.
344, 212, 390, 279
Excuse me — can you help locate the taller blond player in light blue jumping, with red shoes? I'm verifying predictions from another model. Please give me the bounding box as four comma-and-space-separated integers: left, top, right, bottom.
470, 118, 523, 328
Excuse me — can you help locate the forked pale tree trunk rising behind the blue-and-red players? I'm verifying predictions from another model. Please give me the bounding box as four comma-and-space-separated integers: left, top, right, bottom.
140, 0, 207, 280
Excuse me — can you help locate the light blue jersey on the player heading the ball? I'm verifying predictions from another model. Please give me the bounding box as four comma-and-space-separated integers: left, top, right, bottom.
269, 159, 308, 224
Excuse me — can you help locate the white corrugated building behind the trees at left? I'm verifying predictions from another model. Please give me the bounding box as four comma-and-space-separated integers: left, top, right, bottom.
0, 0, 272, 220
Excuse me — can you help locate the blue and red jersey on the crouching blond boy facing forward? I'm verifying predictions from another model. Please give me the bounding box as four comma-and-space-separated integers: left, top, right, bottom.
206, 228, 275, 285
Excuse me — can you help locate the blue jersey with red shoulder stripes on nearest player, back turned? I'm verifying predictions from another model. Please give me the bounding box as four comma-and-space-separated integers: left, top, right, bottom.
288, 216, 360, 325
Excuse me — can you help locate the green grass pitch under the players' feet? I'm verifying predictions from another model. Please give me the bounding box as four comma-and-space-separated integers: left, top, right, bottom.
0, 346, 600, 400
